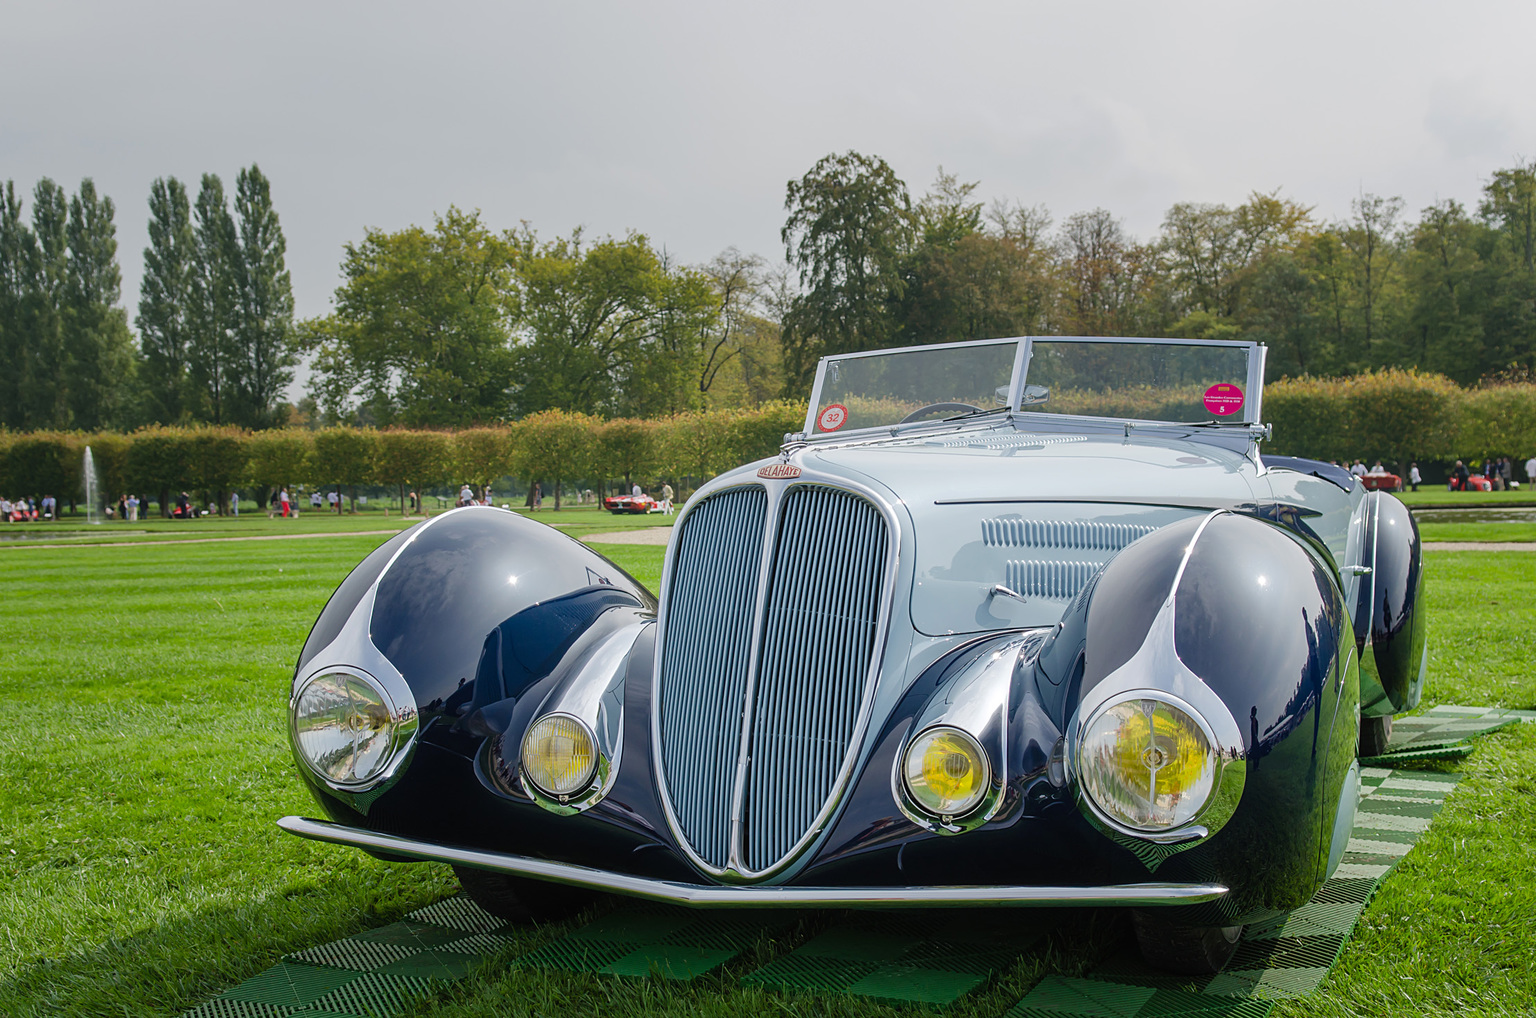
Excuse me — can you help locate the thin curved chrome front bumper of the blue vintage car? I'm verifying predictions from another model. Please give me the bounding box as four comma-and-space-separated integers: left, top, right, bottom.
278, 817, 1227, 909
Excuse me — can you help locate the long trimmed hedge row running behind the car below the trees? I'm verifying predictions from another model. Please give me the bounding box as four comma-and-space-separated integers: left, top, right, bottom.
0, 370, 1536, 505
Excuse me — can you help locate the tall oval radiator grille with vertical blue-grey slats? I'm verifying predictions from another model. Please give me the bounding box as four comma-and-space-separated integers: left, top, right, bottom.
659, 485, 889, 872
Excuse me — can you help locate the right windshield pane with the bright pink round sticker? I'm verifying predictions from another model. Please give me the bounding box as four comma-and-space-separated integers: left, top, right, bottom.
1023, 339, 1252, 424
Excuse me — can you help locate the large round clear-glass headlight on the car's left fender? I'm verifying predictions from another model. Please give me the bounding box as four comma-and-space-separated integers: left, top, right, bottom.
292, 671, 415, 789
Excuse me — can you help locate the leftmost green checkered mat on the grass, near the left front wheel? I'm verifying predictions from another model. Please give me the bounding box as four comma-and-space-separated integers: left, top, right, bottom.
186, 897, 518, 1018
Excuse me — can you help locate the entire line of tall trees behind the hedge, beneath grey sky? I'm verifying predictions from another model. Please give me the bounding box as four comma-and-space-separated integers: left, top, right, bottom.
0, 152, 1536, 430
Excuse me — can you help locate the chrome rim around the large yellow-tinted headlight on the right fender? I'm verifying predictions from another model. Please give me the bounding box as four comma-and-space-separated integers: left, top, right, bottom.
1068, 688, 1247, 843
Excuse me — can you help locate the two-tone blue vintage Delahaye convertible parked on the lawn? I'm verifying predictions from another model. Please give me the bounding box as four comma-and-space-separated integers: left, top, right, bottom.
281, 338, 1425, 970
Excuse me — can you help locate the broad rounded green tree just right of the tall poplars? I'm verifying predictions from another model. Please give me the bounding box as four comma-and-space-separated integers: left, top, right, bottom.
303, 206, 518, 427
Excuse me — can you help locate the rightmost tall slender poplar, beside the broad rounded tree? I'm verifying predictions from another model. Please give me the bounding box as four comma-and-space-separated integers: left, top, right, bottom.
230, 163, 298, 428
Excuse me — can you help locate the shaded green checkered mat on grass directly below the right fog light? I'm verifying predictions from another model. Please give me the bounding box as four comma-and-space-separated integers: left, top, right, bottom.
743, 911, 1049, 1004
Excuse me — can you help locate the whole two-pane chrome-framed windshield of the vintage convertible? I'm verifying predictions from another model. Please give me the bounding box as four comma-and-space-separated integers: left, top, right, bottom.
806, 336, 1258, 435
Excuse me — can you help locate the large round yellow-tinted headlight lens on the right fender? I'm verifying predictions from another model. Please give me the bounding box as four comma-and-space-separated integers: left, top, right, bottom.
1078, 699, 1218, 831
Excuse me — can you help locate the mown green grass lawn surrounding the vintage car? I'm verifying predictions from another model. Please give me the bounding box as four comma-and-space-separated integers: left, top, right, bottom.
0, 528, 1536, 1018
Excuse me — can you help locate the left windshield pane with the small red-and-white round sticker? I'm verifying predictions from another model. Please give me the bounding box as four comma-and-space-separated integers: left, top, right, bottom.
811, 342, 1018, 435
